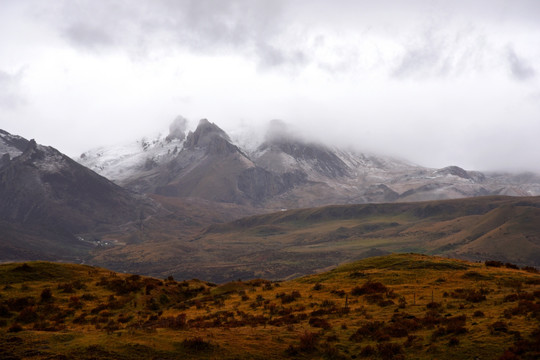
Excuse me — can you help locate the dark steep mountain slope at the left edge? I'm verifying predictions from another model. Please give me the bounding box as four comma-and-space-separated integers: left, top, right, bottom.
0, 131, 155, 259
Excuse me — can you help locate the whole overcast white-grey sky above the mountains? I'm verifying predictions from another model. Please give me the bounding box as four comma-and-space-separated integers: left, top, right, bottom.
0, 0, 540, 172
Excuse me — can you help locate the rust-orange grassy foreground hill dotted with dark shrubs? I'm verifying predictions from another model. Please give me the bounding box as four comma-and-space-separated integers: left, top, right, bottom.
0, 254, 540, 359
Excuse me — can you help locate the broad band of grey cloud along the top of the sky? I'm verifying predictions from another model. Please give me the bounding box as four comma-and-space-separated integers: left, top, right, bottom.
27, 0, 540, 79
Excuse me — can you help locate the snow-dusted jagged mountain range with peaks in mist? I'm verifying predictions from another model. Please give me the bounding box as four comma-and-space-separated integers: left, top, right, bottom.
79, 117, 540, 209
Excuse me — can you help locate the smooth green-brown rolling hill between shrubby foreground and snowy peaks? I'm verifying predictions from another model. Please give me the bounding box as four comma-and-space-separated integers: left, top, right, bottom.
92, 197, 540, 282
